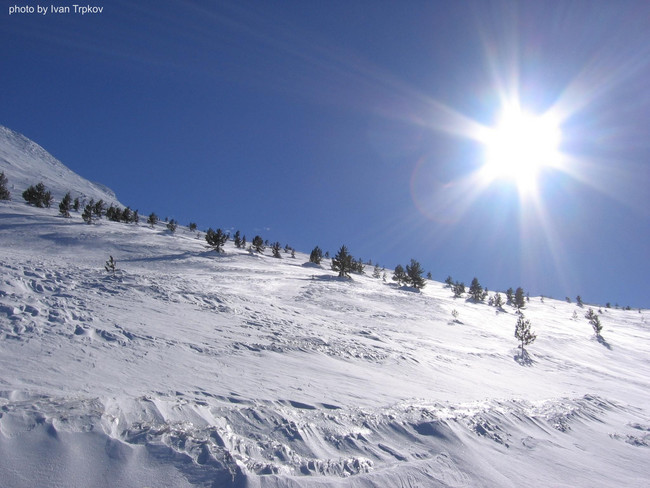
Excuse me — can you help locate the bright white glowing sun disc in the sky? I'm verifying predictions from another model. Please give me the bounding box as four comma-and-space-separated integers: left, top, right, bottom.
481, 106, 561, 195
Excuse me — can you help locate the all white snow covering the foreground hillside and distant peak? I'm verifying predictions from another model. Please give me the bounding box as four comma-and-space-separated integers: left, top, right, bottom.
0, 129, 650, 488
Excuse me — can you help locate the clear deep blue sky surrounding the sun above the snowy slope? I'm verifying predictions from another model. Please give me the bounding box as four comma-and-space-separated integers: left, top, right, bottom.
0, 0, 650, 307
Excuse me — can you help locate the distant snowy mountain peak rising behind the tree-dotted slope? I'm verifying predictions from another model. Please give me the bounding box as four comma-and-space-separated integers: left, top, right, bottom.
0, 125, 119, 204
